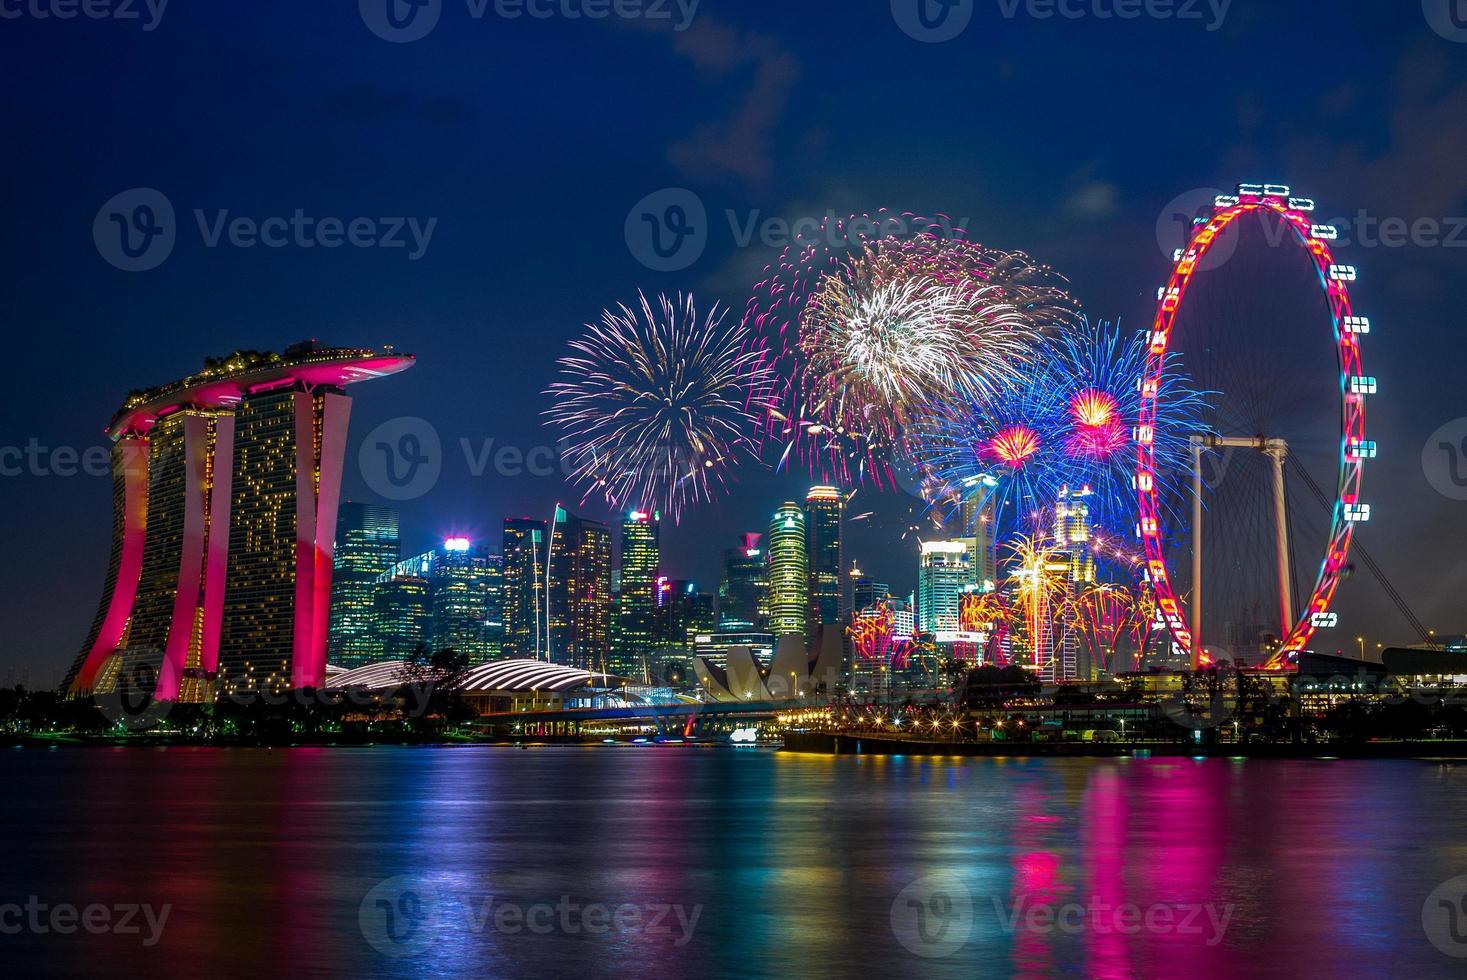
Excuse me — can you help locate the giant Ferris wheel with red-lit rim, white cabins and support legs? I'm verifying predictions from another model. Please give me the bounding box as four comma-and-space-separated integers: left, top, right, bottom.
1135, 183, 1376, 669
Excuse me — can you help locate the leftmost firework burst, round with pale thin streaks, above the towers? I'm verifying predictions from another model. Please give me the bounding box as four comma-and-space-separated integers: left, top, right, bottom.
546, 293, 772, 521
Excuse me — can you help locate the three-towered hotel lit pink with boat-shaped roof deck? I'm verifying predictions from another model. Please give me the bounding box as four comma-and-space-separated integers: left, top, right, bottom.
62, 342, 414, 701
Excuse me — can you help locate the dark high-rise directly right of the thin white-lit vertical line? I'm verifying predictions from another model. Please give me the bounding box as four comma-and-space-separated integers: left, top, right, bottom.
547, 508, 612, 670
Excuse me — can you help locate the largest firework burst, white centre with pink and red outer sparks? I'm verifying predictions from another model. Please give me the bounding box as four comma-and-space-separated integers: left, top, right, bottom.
744, 213, 1075, 486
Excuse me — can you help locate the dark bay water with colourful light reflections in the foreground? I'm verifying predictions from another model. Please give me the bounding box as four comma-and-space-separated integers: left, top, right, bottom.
0, 747, 1467, 979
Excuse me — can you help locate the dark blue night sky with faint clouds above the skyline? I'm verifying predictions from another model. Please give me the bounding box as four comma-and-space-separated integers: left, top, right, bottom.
0, 0, 1467, 685
